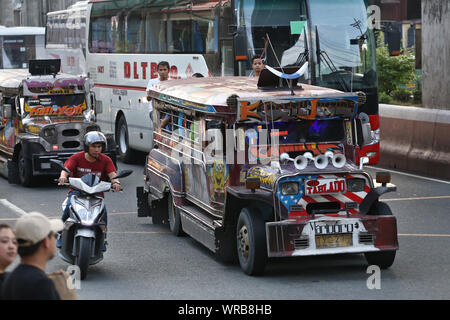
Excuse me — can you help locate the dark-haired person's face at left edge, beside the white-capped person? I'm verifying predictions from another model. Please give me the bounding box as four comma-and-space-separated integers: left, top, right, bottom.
0, 224, 17, 293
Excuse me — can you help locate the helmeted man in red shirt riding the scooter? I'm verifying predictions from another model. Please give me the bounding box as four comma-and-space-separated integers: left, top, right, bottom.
56, 131, 121, 251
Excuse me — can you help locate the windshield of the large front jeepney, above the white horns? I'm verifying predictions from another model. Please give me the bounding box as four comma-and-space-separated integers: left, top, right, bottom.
246, 120, 345, 145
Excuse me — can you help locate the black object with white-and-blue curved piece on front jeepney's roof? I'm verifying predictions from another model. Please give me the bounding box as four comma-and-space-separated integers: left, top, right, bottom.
258, 62, 308, 95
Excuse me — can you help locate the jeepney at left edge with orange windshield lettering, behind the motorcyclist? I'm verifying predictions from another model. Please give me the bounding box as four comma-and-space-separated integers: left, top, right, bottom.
0, 60, 116, 187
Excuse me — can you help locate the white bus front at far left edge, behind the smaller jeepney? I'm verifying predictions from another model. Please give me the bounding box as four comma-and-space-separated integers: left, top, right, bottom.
0, 26, 45, 69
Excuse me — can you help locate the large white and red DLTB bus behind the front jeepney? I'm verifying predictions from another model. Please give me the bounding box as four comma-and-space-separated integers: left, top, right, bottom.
86, 0, 379, 163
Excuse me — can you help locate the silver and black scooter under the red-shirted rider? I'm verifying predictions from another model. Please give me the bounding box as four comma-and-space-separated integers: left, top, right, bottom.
50, 159, 133, 280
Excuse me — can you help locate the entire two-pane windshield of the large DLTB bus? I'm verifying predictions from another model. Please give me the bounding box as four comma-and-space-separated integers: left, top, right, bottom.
235, 0, 377, 91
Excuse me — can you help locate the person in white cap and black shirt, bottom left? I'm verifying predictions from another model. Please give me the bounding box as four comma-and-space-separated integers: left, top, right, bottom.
1, 212, 64, 300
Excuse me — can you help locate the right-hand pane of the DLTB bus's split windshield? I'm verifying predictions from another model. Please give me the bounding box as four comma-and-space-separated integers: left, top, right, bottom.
309, 0, 377, 91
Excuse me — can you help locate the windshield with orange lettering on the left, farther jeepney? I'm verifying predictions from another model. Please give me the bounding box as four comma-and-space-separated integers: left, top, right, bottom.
22, 94, 89, 120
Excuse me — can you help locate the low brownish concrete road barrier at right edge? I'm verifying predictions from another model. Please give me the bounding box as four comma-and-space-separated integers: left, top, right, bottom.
379, 104, 450, 179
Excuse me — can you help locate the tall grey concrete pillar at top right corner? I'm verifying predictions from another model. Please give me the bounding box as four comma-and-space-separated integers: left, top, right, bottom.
422, 0, 450, 110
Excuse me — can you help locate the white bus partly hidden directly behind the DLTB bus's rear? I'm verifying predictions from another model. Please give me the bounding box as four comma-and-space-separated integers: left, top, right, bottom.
45, 1, 88, 75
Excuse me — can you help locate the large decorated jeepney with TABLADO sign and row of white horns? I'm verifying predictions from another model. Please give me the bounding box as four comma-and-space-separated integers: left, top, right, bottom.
136, 70, 398, 275
